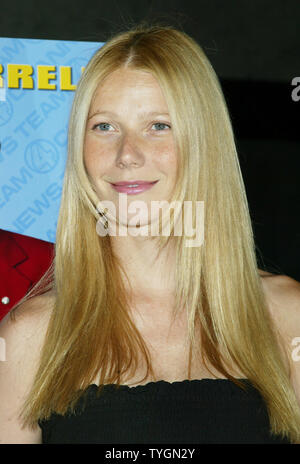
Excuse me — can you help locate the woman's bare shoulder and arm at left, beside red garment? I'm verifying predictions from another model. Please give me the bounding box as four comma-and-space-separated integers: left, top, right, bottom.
0, 292, 55, 444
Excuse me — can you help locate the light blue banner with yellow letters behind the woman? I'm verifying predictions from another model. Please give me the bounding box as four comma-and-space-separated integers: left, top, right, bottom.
0, 38, 103, 242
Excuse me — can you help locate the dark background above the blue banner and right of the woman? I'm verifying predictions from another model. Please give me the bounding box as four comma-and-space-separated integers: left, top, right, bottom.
0, 0, 300, 281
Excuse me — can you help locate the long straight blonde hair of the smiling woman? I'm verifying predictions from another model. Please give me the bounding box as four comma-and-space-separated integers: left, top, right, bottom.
12, 24, 300, 442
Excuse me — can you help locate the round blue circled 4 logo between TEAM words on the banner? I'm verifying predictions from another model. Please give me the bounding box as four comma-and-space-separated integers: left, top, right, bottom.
25, 139, 59, 174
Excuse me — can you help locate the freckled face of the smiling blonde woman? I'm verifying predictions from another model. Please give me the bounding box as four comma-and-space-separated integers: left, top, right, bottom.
84, 68, 177, 227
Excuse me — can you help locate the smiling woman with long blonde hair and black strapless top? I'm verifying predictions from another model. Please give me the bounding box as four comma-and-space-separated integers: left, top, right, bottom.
0, 25, 300, 443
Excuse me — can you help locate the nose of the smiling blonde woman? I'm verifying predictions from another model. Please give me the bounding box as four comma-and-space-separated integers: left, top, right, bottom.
116, 134, 144, 168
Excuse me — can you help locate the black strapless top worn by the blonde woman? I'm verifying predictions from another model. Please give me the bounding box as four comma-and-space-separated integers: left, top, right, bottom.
39, 379, 289, 444
